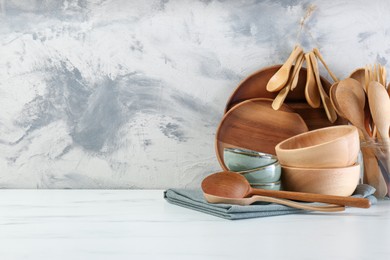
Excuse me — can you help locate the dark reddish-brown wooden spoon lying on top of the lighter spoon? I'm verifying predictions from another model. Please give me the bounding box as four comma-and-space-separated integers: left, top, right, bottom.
202, 172, 370, 208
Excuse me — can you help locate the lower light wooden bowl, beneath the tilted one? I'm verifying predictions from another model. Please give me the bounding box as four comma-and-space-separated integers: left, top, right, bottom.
282, 164, 360, 196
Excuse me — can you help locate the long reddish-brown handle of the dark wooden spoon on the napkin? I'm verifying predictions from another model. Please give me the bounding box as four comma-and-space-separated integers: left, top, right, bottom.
249, 188, 371, 208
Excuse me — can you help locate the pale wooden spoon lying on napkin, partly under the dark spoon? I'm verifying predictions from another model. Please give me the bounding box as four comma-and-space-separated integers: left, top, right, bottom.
204, 193, 345, 212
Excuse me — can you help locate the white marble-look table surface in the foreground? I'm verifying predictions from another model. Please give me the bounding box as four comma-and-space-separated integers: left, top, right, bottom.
0, 190, 390, 260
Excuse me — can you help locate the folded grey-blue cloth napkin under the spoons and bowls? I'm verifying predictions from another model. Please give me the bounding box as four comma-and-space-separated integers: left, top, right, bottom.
164, 184, 377, 220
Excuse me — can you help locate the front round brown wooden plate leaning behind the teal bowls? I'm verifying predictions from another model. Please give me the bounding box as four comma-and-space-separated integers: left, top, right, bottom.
215, 98, 308, 170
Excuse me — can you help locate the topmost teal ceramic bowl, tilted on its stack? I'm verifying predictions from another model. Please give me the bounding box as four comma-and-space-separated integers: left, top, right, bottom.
223, 148, 278, 172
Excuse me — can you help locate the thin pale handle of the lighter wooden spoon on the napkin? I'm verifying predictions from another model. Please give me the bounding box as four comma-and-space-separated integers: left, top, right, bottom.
250, 195, 345, 212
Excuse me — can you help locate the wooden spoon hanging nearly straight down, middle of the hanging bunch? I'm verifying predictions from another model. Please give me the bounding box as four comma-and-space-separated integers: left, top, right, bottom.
305, 53, 321, 108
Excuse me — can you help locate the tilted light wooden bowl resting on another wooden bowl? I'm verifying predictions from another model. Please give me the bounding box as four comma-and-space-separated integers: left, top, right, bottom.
275, 125, 360, 168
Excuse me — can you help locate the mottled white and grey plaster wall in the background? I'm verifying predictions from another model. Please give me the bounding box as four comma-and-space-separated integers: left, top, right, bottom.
0, 0, 390, 188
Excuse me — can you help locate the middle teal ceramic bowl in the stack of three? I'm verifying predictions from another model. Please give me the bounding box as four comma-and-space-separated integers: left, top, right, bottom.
237, 161, 282, 184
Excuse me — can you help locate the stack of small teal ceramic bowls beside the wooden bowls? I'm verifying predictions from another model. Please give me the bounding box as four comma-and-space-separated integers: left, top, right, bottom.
223, 148, 281, 190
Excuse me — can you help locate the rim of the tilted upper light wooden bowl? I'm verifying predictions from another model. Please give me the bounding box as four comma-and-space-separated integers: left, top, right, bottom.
275, 125, 359, 153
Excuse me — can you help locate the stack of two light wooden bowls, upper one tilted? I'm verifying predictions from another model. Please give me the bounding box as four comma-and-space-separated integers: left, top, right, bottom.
275, 125, 360, 196
